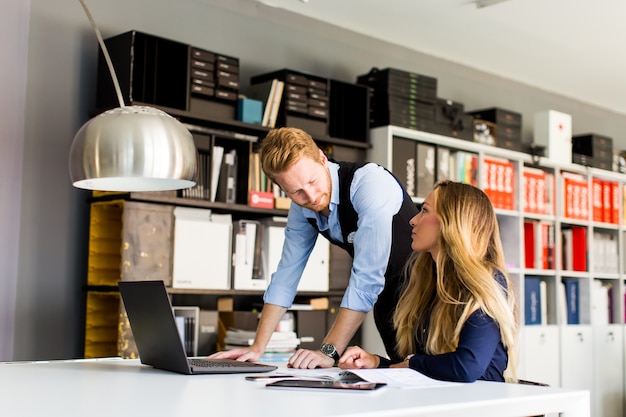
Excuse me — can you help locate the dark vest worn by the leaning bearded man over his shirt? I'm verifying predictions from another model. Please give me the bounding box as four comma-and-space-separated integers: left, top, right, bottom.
308, 162, 418, 360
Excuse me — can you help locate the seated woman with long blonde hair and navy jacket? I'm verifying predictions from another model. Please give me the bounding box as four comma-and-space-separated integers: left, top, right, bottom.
338, 181, 518, 382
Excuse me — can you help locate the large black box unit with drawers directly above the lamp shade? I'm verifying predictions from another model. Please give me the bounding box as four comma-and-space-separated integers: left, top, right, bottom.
96, 30, 239, 120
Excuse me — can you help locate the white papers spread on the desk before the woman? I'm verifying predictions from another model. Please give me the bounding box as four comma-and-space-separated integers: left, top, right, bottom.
280, 368, 460, 388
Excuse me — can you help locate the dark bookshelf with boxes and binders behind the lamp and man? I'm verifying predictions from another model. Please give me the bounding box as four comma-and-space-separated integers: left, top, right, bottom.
84, 30, 369, 364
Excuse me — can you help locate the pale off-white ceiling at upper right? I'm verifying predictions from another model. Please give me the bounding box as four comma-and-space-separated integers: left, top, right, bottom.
256, 0, 626, 115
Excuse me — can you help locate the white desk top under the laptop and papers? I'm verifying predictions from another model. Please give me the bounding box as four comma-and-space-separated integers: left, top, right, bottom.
0, 359, 590, 417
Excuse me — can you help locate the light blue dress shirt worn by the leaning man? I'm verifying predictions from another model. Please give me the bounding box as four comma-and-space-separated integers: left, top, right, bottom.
263, 161, 403, 312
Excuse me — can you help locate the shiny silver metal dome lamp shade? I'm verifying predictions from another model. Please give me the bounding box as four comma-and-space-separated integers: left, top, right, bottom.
69, 106, 197, 192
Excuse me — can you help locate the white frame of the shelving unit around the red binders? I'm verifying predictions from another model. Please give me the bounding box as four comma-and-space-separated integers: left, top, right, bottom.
364, 126, 626, 417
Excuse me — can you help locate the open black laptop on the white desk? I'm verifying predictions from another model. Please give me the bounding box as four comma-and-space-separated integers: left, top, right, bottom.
118, 281, 277, 375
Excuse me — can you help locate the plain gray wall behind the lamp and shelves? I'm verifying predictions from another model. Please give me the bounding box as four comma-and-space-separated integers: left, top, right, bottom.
6, 0, 626, 359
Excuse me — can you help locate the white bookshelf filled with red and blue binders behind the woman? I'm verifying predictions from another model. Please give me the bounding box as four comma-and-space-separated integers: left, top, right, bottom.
364, 126, 626, 416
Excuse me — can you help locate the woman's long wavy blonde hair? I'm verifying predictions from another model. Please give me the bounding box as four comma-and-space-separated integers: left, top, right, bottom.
394, 181, 518, 381
